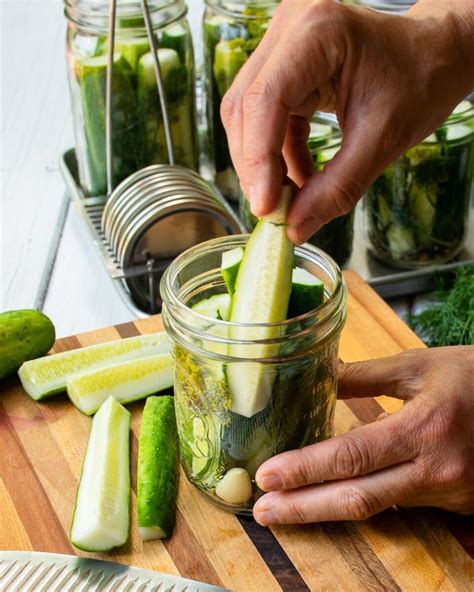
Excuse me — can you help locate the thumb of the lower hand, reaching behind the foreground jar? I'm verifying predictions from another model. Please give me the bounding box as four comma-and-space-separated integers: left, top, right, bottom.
337, 350, 426, 400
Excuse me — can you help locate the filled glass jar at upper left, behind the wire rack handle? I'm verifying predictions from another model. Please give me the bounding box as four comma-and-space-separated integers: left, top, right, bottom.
65, 0, 198, 196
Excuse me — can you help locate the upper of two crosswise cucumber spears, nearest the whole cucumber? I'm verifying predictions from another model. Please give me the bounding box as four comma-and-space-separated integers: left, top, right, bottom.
18, 331, 170, 401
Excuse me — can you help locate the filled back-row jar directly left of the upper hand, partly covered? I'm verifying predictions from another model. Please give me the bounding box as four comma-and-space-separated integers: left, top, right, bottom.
203, 0, 279, 201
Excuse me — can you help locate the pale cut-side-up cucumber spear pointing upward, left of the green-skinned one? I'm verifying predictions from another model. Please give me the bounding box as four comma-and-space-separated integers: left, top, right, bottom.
71, 397, 130, 552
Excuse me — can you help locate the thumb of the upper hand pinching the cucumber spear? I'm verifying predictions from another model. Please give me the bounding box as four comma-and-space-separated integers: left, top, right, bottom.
288, 120, 390, 244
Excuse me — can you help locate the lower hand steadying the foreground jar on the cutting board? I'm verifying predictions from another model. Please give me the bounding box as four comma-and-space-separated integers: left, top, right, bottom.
254, 346, 474, 526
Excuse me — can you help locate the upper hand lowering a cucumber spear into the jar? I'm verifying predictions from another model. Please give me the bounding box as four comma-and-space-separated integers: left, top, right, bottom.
221, 0, 474, 243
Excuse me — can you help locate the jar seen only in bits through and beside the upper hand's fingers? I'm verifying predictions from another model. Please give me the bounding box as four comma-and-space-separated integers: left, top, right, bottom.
239, 114, 354, 266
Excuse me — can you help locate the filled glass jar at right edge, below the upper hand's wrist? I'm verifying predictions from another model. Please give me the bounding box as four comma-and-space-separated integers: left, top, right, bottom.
366, 101, 474, 269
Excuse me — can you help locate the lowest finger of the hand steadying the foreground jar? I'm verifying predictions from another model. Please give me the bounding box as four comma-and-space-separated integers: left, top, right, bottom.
253, 463, 421, 526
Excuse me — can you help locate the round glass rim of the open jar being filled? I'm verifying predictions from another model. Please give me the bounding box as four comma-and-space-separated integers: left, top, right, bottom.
160, 234, 346, 332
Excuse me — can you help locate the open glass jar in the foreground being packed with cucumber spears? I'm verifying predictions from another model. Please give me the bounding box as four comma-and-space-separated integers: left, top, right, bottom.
161, 235, 346, 513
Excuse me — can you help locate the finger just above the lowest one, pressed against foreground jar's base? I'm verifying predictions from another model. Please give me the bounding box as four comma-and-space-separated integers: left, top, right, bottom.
256, 409, 417, 491
